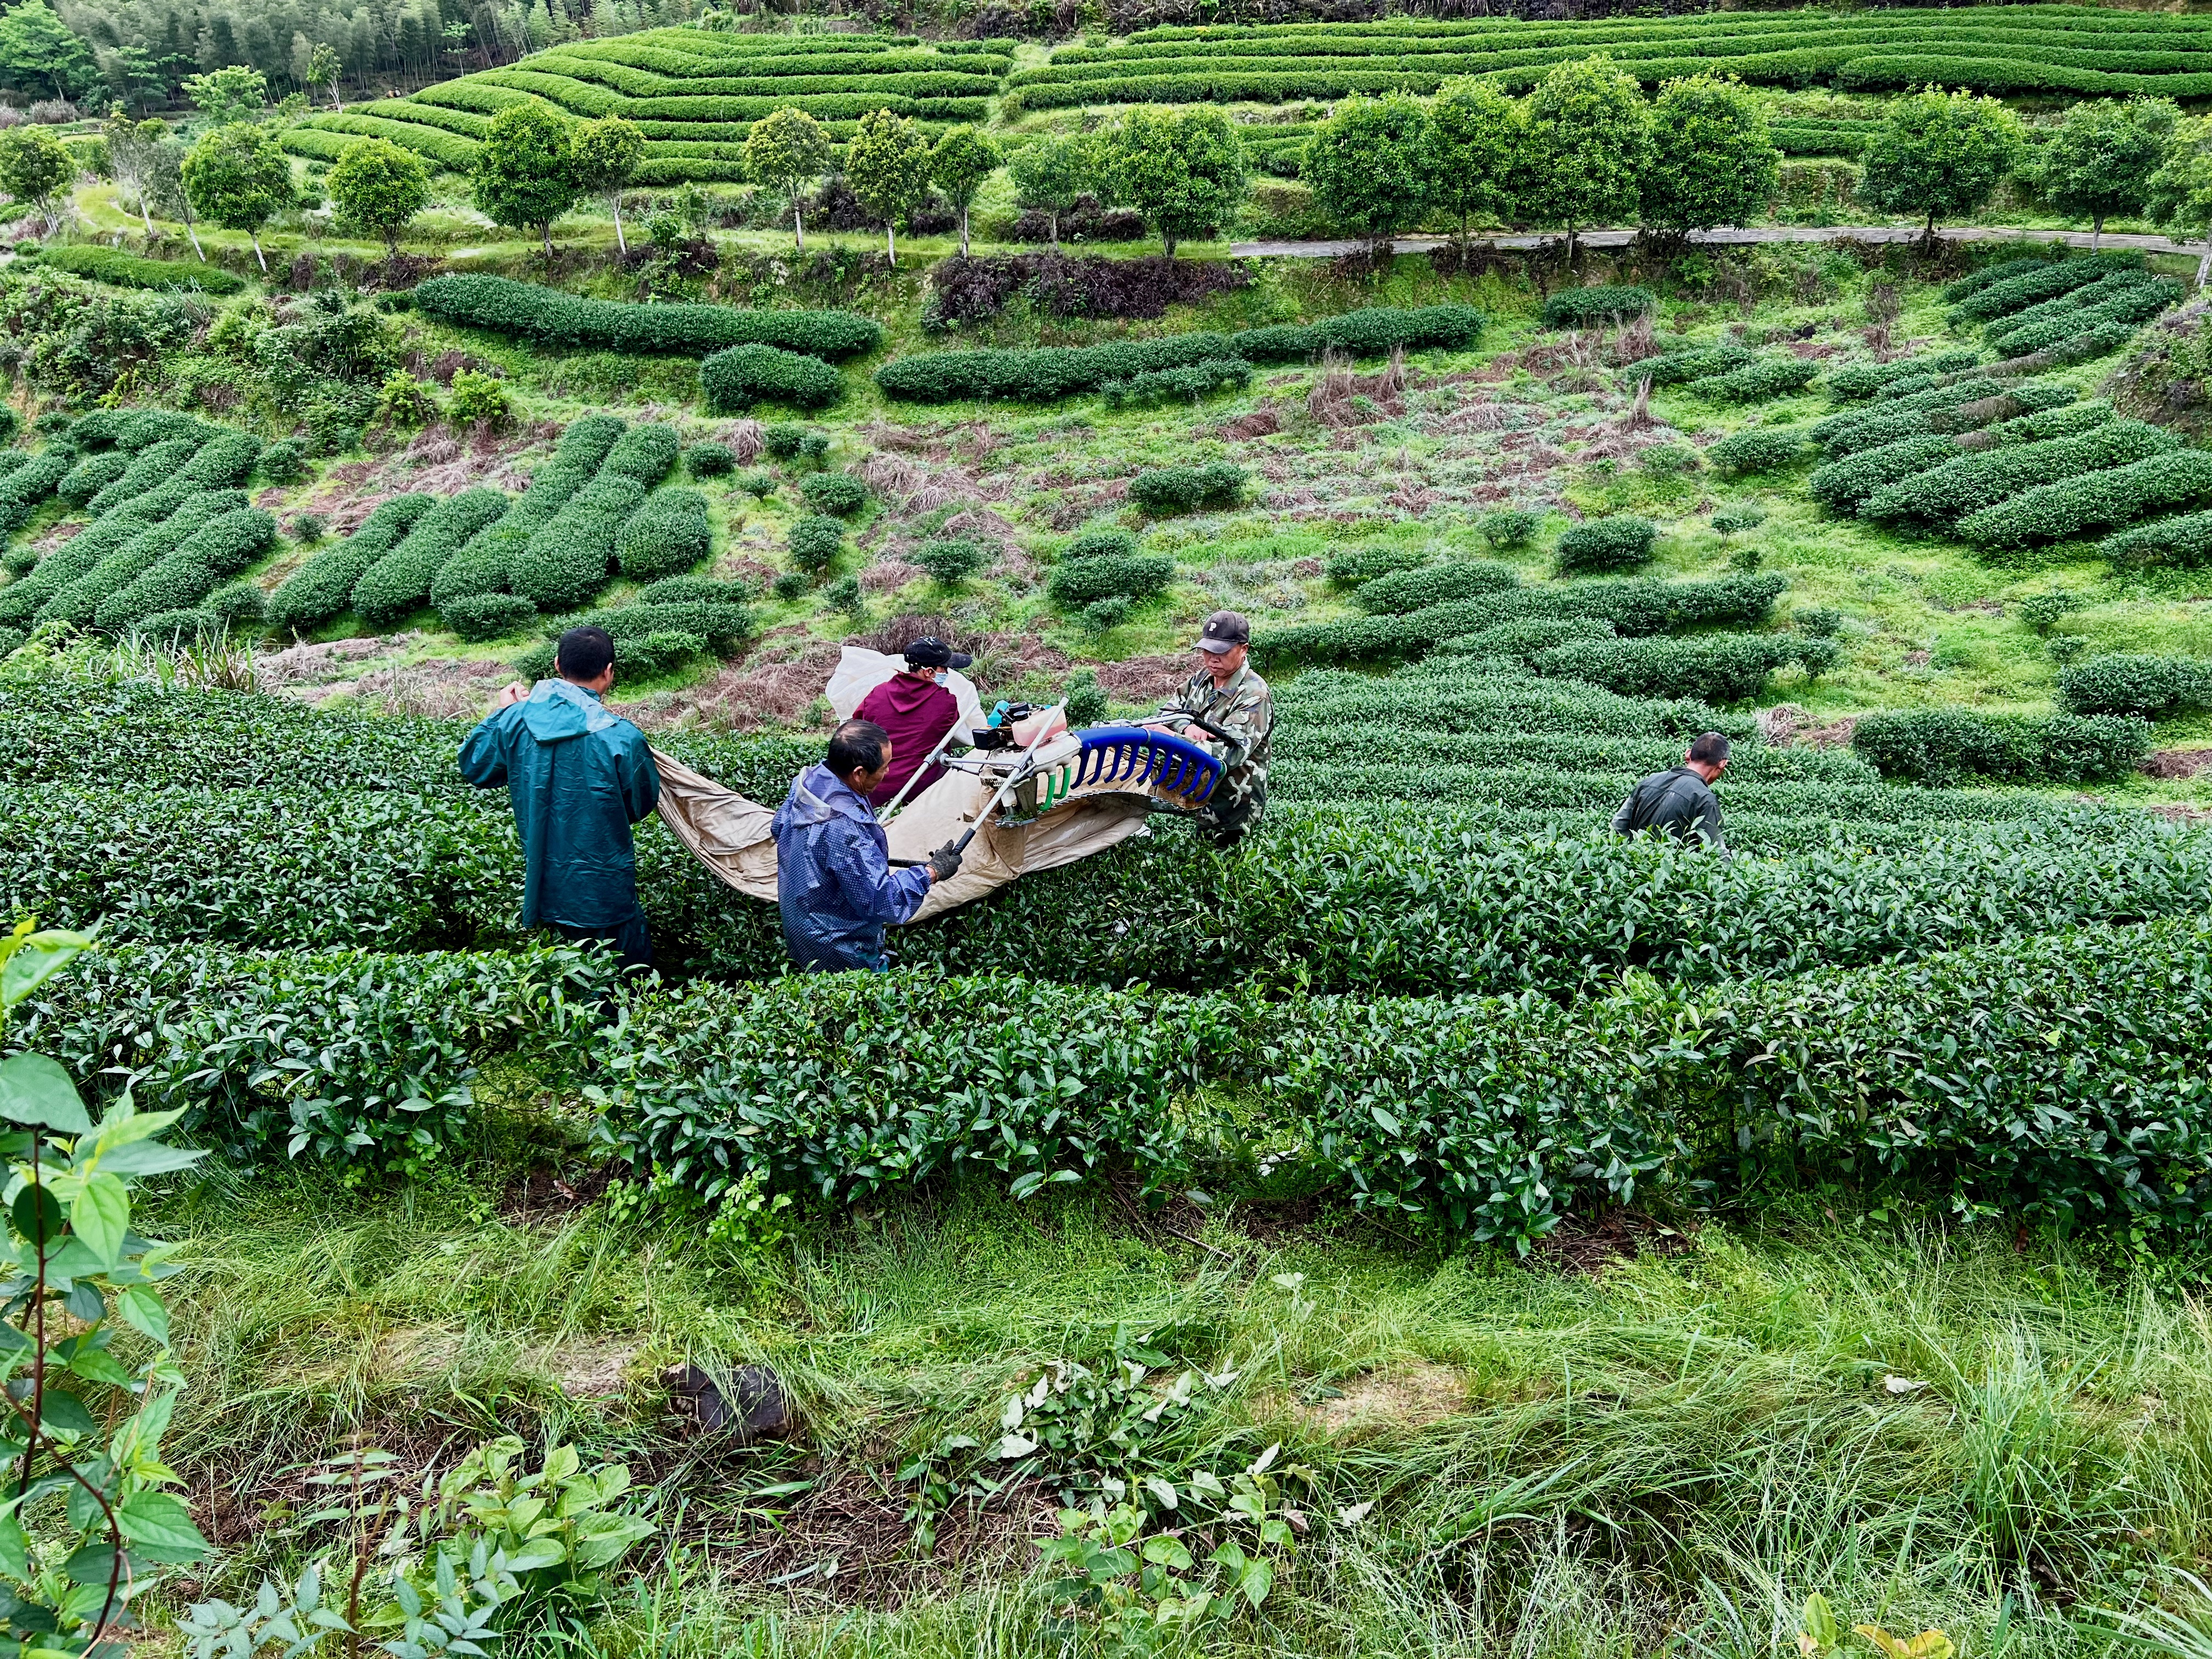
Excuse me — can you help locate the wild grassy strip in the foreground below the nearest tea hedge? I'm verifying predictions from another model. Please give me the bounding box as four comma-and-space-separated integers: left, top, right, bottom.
159, 1126, 2212, 1657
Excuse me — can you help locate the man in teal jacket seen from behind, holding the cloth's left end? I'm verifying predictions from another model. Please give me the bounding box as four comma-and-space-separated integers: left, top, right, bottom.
460, 628, 662, 973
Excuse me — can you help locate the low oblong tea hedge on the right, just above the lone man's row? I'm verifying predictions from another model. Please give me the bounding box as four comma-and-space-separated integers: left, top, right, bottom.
1852, 708, 2150, 787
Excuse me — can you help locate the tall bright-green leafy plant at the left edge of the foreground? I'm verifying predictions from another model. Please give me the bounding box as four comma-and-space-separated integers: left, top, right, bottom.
0, 920, 208, 1659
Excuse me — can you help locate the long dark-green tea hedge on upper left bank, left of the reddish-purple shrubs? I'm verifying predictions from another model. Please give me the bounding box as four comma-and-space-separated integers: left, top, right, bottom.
414, 276, 883, 360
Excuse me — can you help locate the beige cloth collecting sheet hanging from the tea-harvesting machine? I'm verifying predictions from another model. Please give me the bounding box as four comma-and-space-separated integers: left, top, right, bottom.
652, 739, 1153, 922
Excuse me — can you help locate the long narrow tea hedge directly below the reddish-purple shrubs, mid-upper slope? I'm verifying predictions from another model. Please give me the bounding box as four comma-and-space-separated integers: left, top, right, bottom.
876, 305, 1482, 403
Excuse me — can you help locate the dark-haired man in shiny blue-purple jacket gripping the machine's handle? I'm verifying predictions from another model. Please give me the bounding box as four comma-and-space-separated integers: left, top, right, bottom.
774, 721, 960, 973
